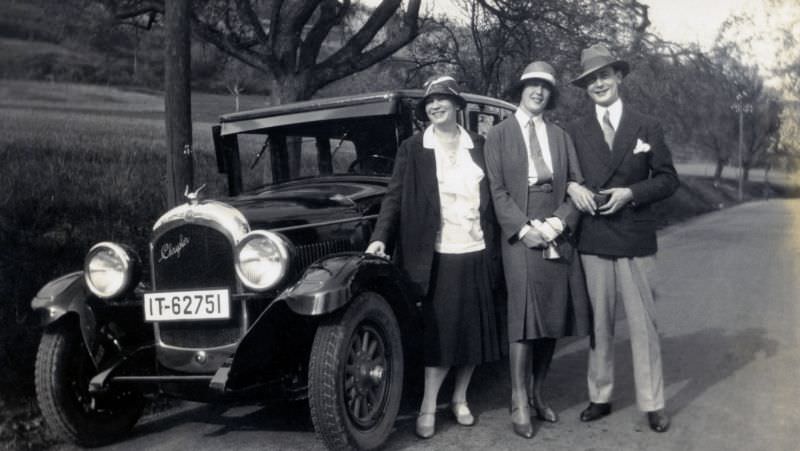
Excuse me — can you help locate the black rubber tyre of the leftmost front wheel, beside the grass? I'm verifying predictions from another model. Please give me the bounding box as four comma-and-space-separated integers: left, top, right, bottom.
36, 321, 145, 447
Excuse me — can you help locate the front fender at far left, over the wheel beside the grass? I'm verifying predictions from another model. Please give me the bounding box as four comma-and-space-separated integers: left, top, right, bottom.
31, 271, 97, 364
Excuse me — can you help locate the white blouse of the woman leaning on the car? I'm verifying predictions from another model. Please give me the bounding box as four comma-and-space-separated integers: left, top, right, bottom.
422, 125, 486, 254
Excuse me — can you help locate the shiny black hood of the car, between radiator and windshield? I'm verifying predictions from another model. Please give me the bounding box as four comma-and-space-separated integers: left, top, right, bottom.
220, 177, 387, 229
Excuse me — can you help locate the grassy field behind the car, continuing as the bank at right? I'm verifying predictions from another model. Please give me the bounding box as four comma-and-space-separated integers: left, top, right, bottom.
0, 80, 786, 449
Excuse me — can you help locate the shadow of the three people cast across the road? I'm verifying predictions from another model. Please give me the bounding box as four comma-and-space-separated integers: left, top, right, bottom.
428, 328, 778, 424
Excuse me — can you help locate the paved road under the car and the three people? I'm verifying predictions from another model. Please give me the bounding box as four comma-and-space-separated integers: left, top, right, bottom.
53, 200, 800, 451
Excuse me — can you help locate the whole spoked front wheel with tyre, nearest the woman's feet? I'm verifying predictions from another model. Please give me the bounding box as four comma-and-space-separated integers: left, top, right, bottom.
308, 292, 403, 449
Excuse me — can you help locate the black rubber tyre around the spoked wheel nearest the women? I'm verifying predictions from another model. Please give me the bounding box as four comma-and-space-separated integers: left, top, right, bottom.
308, 292, 403, 450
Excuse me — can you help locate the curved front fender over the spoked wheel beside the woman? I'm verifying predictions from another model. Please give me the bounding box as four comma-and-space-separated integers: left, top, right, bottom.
276, 252, 402, 316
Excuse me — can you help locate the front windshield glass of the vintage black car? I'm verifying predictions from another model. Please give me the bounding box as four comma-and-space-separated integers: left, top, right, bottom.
237, 116, 398, 191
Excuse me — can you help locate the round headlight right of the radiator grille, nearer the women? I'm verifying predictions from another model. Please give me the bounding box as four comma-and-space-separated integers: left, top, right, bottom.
236, 230, 291, 291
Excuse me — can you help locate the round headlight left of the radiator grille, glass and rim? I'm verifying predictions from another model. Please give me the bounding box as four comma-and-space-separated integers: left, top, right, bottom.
83, 241, 141, 299
